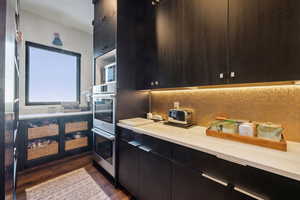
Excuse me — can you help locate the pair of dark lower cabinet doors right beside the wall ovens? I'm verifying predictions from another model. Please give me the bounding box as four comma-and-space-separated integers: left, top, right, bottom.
119, 140, 171, 200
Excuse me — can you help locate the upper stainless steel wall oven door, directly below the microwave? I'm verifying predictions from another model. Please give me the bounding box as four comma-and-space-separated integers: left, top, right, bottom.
93, 94, 116, 135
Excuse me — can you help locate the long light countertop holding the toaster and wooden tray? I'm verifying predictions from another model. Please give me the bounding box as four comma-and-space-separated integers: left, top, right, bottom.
117, 122, 300, 181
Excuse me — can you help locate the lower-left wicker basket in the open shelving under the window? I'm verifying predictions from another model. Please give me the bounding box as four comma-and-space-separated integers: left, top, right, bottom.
27, 142, 58, 160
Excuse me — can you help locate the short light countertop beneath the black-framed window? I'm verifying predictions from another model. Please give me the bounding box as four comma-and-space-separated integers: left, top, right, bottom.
19, 111, 92, 120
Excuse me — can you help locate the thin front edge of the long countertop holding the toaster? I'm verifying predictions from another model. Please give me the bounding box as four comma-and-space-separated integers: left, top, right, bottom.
117, 123, 300, 181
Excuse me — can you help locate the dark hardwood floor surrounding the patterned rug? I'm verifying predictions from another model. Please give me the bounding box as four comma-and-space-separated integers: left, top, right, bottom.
17, 154, 131, 200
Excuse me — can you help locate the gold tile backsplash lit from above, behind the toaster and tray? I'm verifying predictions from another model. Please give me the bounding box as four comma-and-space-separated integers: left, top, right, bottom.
151, 85, 300, 142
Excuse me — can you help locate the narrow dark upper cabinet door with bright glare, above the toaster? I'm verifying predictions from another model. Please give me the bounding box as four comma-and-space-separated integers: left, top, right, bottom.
155, 0, 185, 88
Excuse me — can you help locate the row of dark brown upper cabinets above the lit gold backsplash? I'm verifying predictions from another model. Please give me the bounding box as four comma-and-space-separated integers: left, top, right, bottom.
115, 0, 300, 89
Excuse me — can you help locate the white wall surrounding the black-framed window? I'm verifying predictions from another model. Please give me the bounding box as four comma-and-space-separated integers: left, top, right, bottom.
20, 10, 93, 114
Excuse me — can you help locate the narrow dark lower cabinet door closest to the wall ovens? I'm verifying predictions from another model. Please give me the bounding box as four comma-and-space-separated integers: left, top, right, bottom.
119, 140, 139, 196
